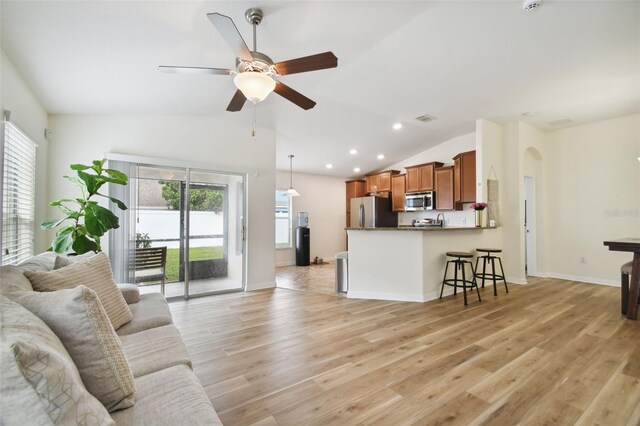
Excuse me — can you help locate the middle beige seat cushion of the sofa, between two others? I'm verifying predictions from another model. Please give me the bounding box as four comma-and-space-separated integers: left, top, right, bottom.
120, 324, 191, 377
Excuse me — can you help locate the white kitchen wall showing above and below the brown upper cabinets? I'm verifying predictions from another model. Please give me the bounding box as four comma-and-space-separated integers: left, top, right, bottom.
388, 133, 477, 226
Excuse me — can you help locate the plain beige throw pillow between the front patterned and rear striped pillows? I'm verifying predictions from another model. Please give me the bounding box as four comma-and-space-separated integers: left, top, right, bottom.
13, 285, 136, 411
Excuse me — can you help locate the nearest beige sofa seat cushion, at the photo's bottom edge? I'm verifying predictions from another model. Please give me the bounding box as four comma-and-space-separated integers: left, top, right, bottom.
111, 365, 222, 426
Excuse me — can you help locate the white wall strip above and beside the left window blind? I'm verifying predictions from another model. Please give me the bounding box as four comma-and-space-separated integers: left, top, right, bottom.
0, 52, 50, 253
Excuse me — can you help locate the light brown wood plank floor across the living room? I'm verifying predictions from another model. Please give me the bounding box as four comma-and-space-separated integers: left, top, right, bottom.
171, 269, 640, 426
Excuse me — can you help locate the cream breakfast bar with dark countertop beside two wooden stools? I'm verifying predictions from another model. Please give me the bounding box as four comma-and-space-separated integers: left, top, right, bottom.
346, 227, 500, 302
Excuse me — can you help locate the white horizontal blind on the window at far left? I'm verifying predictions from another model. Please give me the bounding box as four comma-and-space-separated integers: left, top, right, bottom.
0, 121, 36, 265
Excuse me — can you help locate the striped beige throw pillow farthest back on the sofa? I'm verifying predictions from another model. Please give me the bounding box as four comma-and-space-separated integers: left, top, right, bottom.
24, 253, 133, 329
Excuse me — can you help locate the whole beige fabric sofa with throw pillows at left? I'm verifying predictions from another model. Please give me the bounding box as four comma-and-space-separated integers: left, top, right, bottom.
0, 253, 221, 426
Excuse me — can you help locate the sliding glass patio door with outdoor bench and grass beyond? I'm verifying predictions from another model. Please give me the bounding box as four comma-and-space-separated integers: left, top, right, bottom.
110, 162, 245, 298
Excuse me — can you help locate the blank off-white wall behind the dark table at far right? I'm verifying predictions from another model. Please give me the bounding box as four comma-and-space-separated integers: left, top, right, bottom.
545, 114, 640, 284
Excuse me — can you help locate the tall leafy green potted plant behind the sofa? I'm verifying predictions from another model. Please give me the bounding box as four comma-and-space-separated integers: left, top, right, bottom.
41, 159, 128, 254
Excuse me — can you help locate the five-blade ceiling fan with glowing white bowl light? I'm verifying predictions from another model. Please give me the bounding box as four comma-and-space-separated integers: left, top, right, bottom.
158, 8, 338, 111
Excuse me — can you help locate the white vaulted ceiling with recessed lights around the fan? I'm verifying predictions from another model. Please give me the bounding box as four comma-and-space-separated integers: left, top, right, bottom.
0, 0, 640, 177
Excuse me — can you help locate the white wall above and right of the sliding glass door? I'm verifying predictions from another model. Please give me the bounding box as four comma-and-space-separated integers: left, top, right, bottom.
48, 115, 275, 290
